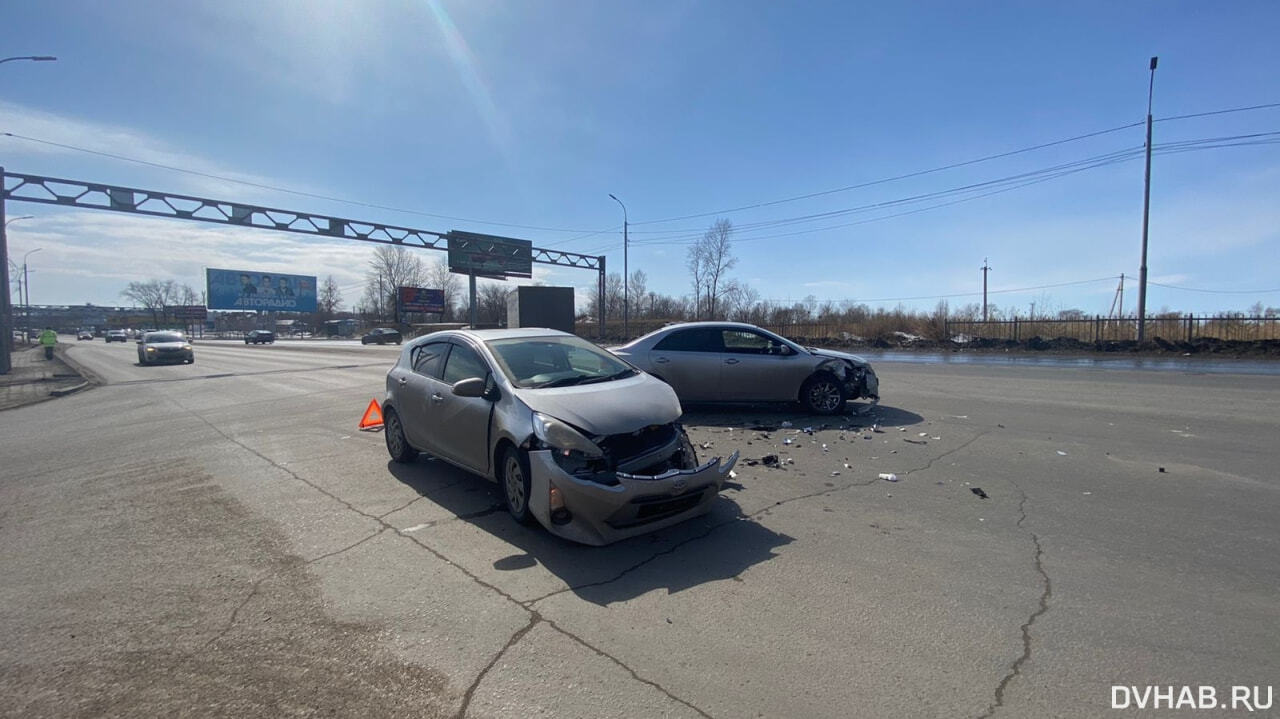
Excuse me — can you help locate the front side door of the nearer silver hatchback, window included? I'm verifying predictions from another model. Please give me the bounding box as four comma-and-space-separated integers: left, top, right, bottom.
430, 340, 493, 473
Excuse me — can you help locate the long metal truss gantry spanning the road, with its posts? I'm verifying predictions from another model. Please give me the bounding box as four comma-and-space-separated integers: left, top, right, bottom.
0, 168, 604, 374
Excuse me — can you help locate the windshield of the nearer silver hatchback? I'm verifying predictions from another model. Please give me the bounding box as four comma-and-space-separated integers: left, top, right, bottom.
485, 336, 636, 389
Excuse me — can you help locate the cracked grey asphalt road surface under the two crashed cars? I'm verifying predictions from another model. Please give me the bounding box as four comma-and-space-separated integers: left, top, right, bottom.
0, 342, 1280, 718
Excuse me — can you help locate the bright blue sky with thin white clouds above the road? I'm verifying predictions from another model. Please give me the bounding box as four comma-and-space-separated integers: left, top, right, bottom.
0, 0, 1280, 313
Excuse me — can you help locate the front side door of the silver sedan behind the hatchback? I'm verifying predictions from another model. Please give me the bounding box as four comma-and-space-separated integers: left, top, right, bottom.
721, 328, 809, 402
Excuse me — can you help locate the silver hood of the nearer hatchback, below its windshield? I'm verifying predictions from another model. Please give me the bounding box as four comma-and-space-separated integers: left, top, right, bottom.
513, 372, 682, 435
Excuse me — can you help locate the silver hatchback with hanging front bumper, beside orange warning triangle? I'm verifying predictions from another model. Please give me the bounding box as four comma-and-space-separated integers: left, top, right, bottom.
383, 329, 737, 545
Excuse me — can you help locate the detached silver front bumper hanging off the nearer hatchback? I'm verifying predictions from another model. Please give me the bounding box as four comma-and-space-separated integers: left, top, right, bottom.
529, 449, 737, 546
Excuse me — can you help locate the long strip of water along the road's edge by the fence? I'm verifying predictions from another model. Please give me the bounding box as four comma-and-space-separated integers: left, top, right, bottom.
855, 351, 1280, 376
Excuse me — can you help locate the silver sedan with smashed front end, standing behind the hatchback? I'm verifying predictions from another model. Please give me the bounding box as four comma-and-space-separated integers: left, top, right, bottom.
612, 322, 879, 415
